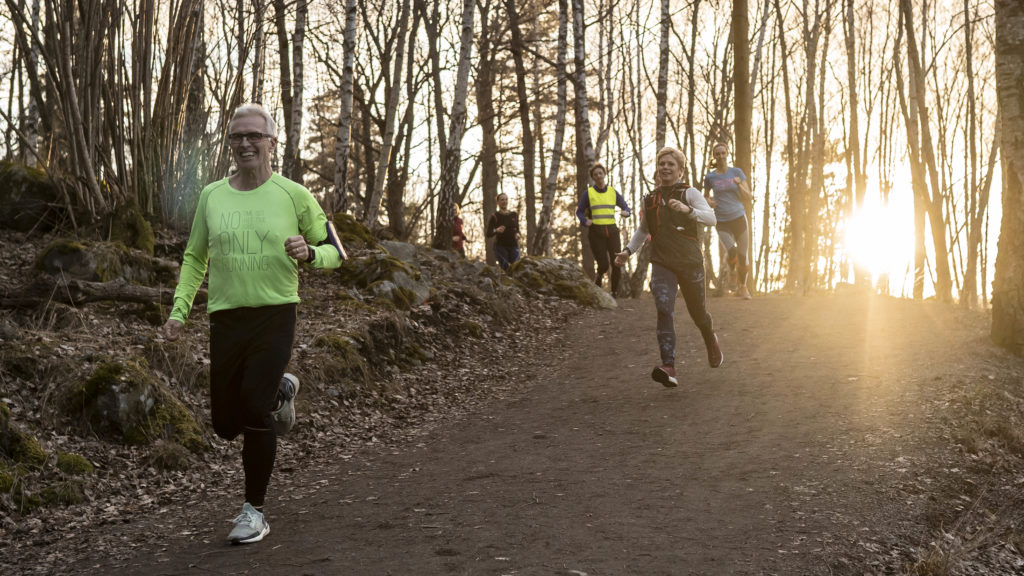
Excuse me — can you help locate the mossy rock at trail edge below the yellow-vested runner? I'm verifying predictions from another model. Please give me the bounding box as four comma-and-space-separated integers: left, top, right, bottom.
508, 256, 618, 308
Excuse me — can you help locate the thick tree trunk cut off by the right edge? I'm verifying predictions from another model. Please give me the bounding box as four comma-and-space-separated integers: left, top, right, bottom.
991, 0, 1024, 356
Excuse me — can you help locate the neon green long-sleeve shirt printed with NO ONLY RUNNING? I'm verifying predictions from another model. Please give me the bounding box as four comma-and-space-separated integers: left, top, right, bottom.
171, 173, 341, 322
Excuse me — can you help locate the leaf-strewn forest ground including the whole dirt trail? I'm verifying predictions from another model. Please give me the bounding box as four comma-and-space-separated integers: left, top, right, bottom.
0, 226, 1024, 576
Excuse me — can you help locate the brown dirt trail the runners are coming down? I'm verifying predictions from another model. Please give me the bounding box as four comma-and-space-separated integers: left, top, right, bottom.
61, 295, 991, 576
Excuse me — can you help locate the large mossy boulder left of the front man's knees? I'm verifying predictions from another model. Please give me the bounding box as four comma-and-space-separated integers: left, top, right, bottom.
63, 359, 206, 452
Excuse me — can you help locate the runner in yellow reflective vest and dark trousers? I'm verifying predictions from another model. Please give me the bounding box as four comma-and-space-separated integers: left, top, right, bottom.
577, 162, 630, 295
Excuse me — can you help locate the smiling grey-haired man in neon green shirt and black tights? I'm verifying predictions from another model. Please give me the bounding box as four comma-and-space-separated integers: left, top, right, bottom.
162, 105, 344, 544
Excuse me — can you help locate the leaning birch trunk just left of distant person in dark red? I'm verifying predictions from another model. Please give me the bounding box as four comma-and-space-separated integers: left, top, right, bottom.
432, 0, 475, 249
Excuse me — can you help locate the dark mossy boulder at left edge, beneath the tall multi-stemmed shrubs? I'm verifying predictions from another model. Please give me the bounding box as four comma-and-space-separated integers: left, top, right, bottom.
0, 161, 65, 232
